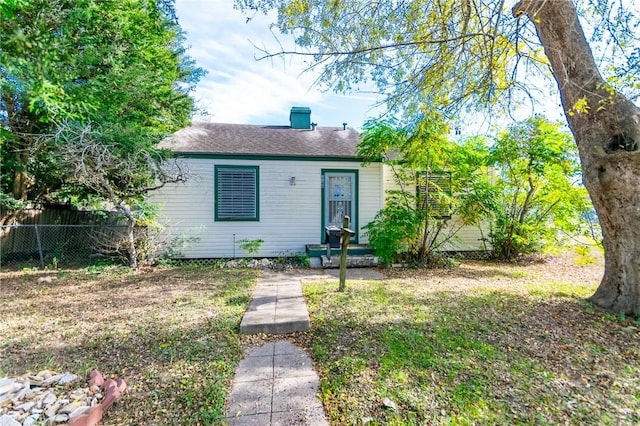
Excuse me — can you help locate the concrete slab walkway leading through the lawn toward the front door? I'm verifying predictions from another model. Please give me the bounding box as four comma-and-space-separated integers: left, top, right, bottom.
226, 271, 329, 426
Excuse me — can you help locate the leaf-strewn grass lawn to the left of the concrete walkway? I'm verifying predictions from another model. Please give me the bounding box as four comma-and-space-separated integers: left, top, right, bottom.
0, 270, 255, 424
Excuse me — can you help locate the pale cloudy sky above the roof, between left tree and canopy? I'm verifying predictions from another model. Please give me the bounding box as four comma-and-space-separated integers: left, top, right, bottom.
176, 0, 376, 129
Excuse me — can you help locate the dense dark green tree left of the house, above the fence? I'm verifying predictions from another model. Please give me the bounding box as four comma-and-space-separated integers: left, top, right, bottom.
0, 0, 202, 206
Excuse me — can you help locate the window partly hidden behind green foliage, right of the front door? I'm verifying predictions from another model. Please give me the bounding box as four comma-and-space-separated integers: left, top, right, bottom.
417, 172, 452, 219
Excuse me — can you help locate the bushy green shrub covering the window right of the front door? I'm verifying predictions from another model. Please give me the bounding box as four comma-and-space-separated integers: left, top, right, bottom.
359, 114, 489, 265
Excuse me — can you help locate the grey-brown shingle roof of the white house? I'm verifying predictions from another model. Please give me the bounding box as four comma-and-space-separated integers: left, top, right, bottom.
159, 123, 360, 158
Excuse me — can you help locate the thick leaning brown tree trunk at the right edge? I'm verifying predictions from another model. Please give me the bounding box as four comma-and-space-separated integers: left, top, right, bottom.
513, 0, 640, 316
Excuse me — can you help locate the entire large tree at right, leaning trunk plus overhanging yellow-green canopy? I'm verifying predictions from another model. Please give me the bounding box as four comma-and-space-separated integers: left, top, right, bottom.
236, 0, 640, 315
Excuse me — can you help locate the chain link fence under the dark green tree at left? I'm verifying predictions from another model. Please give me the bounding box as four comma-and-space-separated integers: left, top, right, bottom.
0, 224, 139, 270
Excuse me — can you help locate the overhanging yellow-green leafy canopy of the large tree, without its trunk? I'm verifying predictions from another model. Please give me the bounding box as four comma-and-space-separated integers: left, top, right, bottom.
236, 0, 640, 112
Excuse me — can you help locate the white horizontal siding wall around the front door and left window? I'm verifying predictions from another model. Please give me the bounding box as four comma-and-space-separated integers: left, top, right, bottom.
150, 158, 383, 258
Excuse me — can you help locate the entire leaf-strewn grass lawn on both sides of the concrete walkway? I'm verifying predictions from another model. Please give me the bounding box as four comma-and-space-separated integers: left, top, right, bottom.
0, 251, 640, 425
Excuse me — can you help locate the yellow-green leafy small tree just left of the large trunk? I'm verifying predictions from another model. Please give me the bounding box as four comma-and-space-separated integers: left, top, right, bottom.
489, 116, 592, 259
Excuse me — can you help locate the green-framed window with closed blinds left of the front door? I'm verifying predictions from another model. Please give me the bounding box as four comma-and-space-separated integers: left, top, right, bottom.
215, 166, 259, 221
